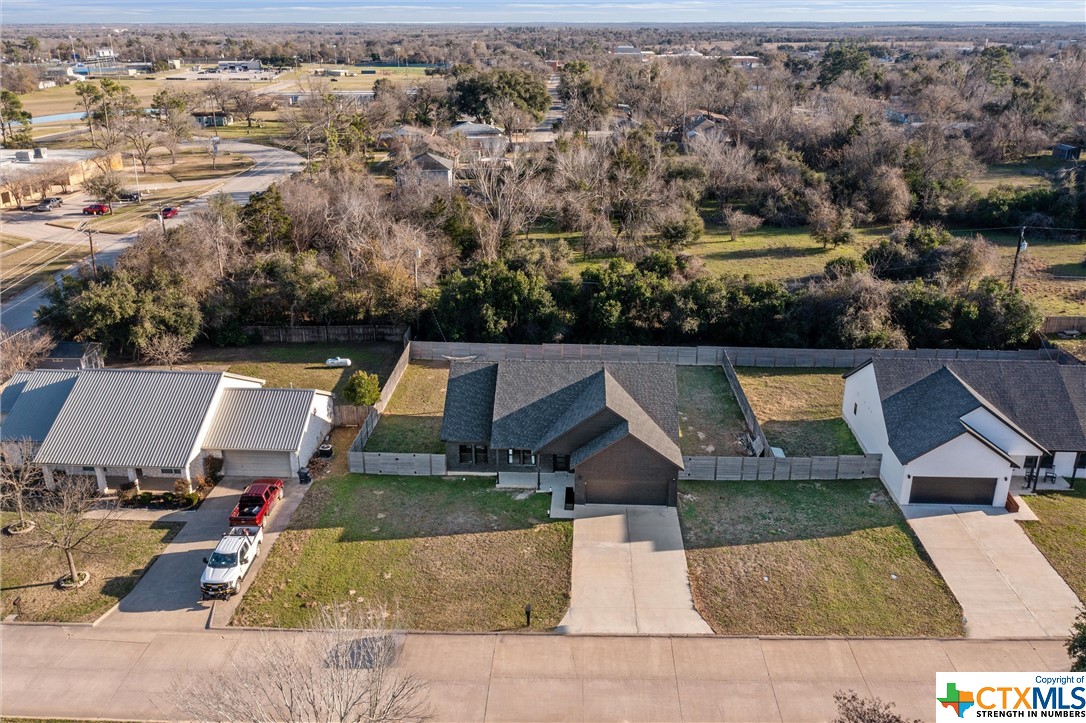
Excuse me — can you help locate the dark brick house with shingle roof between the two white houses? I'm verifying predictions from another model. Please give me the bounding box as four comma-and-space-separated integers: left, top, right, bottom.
441, 359, 683, 506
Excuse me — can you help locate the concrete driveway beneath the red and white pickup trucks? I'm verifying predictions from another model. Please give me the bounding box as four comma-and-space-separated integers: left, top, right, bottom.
98, 477, 308, 632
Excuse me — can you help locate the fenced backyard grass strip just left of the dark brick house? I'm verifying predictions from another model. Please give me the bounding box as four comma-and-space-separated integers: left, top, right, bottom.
366, 362, 449, 455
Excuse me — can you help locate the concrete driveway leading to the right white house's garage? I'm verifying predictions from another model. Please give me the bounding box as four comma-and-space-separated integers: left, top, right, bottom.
901, 505, 1081, 638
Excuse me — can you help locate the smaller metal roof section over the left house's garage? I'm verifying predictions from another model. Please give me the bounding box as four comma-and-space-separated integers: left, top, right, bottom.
203, 389, 318, 452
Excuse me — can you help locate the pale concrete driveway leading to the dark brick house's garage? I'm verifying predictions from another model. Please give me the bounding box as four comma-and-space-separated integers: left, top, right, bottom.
558, 505, 712, 635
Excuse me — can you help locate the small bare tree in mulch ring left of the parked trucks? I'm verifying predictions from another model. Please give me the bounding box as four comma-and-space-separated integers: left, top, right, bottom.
26, 474, 121, 587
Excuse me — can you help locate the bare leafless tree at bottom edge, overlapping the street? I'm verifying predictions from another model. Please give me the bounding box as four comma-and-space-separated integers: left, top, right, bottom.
171, 605, 430, 723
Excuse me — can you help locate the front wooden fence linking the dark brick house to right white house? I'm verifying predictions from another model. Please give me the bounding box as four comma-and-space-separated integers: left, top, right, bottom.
679, 455, 882, 481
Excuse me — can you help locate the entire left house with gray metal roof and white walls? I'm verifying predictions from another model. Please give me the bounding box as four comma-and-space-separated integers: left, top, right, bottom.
0, 369, 332, 492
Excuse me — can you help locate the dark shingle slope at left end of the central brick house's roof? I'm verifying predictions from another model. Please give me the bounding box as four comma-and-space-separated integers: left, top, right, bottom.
441, 362, 497, 444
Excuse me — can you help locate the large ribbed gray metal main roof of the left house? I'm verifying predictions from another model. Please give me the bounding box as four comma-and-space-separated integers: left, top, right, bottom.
35, 369, 231, 467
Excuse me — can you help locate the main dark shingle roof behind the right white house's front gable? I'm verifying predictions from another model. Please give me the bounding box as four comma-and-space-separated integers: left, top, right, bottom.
872, 359, 1086, 452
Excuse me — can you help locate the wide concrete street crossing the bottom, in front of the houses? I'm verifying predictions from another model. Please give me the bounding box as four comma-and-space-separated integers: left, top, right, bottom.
0, 625, 1070, 723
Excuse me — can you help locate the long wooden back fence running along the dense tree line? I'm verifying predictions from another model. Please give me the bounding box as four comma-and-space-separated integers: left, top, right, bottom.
411, 341, 1053, 368
